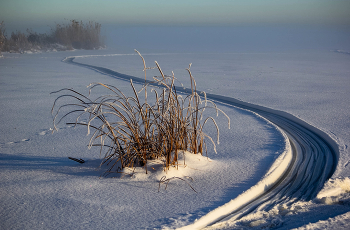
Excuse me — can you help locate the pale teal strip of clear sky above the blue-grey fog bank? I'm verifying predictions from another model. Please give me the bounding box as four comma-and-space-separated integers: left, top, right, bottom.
0, 0, 350, 29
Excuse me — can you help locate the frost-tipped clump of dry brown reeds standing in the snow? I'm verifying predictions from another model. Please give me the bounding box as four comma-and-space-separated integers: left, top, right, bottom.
52, 51, 229, 173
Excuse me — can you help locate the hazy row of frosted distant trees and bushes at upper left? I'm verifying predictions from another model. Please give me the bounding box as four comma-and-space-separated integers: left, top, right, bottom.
0, 20, 104, 53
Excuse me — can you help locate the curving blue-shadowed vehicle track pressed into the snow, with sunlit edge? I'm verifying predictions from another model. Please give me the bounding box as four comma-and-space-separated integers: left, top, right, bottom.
63, 57, 339, 229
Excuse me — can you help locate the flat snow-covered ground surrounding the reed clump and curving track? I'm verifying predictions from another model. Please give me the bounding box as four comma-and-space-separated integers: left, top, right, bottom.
0, 44, 350, 229
